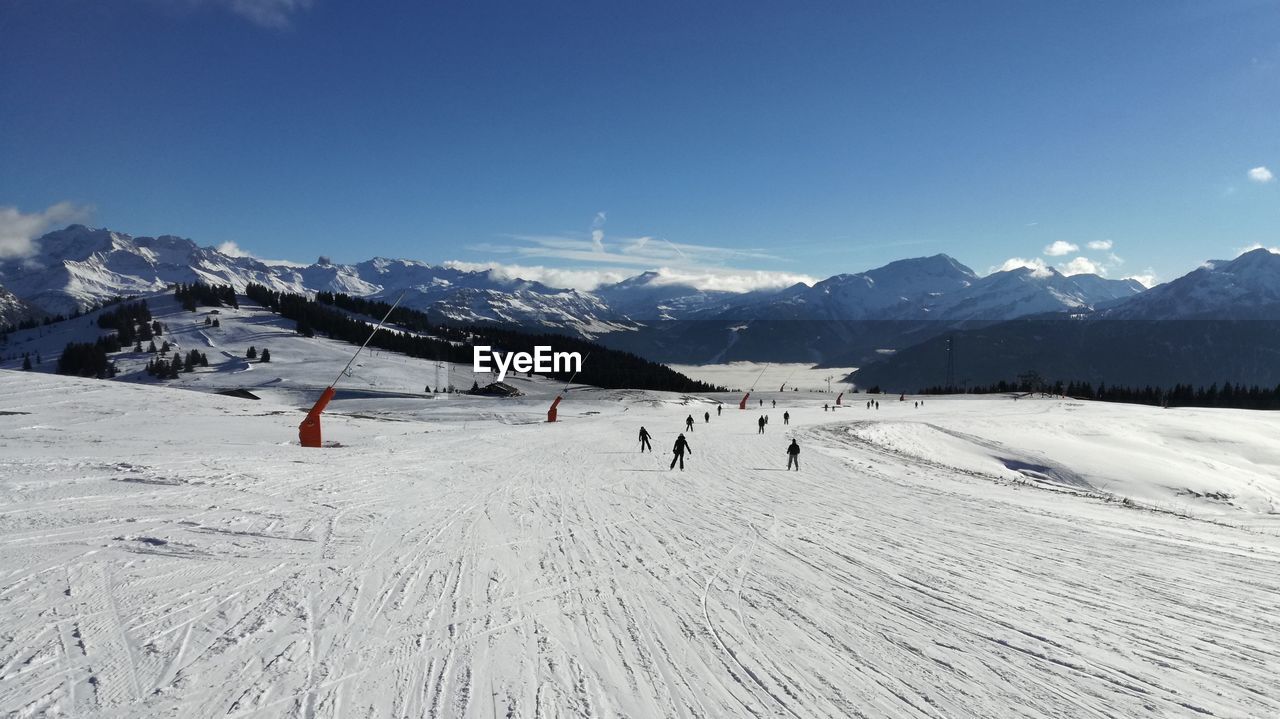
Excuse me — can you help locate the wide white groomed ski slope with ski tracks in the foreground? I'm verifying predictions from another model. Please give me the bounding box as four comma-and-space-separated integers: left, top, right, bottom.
0, 371, 1280, 718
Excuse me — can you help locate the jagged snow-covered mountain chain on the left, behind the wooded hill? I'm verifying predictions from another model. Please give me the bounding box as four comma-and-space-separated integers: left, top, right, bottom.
0, 225, 630, 336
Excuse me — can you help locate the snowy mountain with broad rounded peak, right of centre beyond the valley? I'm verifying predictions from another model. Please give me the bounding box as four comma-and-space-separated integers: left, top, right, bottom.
602, 255, 1143, 366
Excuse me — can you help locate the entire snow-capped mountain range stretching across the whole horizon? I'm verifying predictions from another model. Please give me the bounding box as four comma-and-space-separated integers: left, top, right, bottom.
0, 225, 1280, 386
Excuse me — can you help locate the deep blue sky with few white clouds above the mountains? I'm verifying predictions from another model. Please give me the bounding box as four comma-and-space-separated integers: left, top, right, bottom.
0, 0, 1280, 287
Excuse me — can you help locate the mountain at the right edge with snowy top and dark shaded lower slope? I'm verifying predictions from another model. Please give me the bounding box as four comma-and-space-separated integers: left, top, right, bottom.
852, 249, 1280, 391
